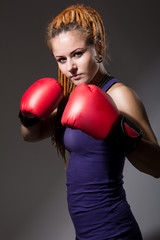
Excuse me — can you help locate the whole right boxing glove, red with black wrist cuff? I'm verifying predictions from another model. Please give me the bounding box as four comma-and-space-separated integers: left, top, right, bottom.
61, 84, 142, 156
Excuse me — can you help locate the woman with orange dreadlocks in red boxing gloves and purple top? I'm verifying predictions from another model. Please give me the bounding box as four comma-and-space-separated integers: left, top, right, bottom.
19, 5, 160, 240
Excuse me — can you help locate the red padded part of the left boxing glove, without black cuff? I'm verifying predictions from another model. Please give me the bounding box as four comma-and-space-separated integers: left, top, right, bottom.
20, 78, 63, 120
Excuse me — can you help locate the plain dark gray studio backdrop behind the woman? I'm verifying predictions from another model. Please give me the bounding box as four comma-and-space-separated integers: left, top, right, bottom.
0, 0, 160, 240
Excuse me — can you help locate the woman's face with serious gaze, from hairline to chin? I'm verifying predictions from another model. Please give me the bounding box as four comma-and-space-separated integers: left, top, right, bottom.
50, 30, 99, 85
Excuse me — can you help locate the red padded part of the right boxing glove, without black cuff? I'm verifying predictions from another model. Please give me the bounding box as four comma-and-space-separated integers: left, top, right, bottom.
61, 83, 120, 139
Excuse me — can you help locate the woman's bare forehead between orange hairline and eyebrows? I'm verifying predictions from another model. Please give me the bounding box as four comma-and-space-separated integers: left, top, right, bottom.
50, 30, 86, 55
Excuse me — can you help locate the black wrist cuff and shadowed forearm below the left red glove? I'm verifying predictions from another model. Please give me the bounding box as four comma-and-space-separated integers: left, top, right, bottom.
21, 110, 57, 142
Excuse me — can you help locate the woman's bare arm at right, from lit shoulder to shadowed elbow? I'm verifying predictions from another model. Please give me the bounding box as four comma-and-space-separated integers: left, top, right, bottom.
108, 84, 160, 178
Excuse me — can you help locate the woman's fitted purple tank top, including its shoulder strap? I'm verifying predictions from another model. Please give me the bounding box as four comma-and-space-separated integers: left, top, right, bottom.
63, 78, 142, 240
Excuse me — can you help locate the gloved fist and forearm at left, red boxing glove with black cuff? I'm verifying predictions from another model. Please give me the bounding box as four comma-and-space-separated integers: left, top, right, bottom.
19, 78, 63, 142
